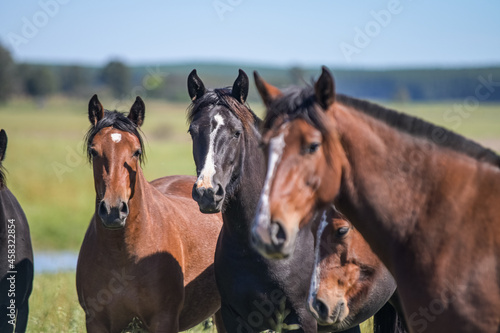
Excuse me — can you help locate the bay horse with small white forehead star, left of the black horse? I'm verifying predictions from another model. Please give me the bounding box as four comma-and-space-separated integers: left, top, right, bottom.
76, 95, 222, 333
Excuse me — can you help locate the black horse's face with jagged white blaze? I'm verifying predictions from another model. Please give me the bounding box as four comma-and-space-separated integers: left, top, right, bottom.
189, 106, 244, 213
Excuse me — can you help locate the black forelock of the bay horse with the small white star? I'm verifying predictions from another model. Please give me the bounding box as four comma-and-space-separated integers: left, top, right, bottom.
85, 110, 145, 163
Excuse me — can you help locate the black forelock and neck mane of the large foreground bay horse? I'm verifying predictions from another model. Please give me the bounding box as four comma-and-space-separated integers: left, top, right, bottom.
264, 86, 500, 167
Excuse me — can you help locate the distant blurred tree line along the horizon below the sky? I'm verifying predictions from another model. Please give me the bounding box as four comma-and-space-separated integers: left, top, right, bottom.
0, 41, 500, 102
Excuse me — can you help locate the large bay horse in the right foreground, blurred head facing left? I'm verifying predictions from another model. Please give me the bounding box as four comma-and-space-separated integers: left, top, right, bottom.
253, 67, 500, 332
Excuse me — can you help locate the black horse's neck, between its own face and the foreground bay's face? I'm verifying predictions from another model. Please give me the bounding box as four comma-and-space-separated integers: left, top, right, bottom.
223, 132, 265, 241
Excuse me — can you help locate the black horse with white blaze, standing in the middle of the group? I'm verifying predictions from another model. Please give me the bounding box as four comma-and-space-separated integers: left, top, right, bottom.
188, 70, 406, 333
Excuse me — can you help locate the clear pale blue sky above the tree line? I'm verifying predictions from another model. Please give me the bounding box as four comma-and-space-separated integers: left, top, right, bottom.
0, 0, 500, 68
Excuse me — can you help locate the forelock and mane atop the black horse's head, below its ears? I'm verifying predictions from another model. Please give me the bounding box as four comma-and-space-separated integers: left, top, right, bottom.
187, 88, 261, 130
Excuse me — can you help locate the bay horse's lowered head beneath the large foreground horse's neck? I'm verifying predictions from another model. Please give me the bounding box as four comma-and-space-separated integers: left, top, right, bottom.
308, 211, 396, 330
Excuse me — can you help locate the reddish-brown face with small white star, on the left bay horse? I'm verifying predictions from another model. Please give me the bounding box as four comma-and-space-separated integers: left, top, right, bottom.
90, 127, 142, 229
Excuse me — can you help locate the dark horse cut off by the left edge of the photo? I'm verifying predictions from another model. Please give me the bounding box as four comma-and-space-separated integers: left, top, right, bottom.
0, 130, 34, 333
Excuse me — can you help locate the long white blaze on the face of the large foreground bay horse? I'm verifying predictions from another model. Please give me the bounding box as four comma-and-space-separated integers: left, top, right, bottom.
255, 129, 287, 228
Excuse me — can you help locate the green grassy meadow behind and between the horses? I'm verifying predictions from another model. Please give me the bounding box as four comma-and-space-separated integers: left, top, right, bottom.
0, 97, 500, 333
